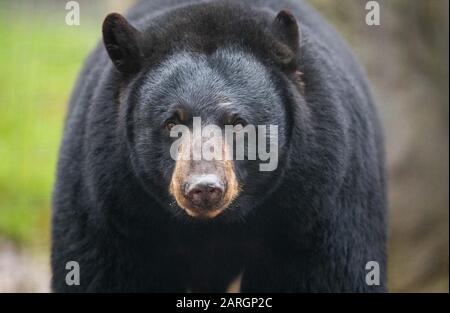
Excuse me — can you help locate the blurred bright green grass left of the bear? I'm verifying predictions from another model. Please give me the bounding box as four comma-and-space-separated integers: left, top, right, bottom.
0, 5, 100, 245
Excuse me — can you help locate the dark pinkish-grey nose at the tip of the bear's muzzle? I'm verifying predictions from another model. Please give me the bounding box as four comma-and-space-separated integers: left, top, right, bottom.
185, 175, 224, 210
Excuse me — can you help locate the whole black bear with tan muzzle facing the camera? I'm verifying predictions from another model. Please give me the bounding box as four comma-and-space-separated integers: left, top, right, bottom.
52, 0, 387, 292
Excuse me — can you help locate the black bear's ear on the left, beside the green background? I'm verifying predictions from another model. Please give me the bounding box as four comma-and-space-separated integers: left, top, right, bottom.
102, 13, 142, 75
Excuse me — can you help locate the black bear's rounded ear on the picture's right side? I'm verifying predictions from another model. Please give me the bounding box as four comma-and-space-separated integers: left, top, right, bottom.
272, 10, 300, 65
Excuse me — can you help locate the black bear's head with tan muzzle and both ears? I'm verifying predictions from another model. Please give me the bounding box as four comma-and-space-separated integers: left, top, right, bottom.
103, 3, 302, 220
